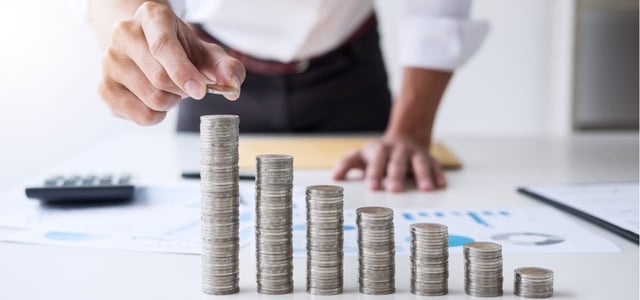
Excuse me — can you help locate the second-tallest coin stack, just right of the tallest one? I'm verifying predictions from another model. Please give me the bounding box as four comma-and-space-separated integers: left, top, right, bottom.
256, 154, 293, 295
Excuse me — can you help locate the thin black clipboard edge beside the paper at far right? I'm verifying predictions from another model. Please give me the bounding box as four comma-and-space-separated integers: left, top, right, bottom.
518, 187, 639, 244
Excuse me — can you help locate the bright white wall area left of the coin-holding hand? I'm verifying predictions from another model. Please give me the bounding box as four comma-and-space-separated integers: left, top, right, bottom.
0, 0, 172, 190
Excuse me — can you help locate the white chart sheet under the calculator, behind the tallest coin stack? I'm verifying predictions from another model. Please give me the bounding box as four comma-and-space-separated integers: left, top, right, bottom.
0, 184, 253, 254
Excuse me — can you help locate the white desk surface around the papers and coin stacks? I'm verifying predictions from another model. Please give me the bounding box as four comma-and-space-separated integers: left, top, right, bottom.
0, 133, 638, 300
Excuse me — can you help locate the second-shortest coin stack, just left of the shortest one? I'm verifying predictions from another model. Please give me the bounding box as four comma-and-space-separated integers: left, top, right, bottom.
463, 242, 503, 297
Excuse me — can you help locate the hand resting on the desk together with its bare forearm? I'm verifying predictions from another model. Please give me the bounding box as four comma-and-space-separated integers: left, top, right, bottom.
333, 67, 452, 192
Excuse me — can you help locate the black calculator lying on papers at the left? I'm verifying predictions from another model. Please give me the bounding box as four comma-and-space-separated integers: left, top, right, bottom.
25, 174, 135, 204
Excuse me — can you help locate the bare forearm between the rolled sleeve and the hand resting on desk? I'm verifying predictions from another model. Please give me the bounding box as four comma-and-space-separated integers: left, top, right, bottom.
386, 67, 453, 143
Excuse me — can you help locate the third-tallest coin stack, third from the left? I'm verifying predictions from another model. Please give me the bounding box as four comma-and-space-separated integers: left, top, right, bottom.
307, 185, 344, 295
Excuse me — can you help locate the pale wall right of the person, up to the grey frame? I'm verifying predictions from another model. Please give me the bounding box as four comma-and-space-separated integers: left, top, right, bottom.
376, 0, 573, 136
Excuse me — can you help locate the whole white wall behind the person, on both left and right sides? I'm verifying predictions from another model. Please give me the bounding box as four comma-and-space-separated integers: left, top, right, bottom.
0, 0, 572, 188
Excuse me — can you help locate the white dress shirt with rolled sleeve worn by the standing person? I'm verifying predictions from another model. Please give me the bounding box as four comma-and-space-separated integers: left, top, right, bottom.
170, 0, 489, 70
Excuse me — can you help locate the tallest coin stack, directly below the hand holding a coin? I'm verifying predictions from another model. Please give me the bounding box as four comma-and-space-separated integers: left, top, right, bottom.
200, 115, 240, 295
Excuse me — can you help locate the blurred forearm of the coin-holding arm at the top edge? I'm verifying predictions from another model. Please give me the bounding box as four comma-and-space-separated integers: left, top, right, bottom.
89, 0, 169, 48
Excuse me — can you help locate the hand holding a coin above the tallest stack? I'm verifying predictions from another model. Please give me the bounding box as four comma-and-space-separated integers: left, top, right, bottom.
98, 2, 245, 125
